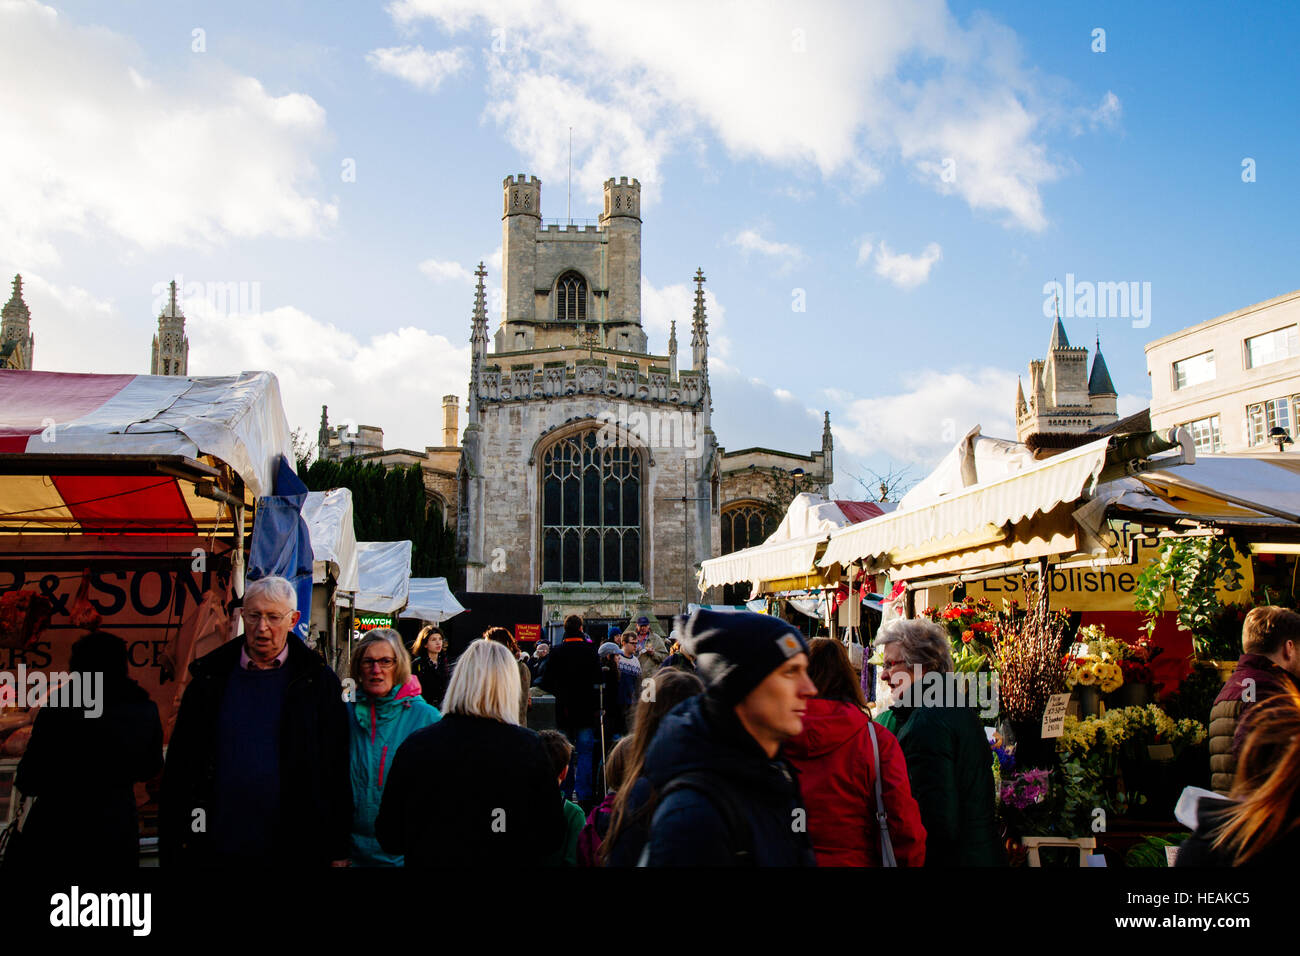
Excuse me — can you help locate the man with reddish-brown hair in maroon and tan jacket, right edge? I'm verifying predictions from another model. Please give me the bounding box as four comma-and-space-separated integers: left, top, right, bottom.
1209, 605, 1300, 793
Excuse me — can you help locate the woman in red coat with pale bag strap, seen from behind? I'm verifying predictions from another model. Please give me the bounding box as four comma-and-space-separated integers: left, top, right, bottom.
784, 637, 926, 866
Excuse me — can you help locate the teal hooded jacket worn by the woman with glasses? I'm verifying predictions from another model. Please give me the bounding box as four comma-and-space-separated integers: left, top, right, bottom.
351, 676, 442, 866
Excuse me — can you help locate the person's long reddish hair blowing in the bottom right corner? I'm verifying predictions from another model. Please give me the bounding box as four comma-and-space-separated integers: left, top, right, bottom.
1175, 687, 1300, 866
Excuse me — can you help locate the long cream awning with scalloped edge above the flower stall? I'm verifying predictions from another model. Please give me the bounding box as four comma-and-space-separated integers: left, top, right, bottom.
818, 438, 1110, 567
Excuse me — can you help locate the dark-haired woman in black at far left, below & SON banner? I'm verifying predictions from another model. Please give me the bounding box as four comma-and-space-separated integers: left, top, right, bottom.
5, 631, 163, 868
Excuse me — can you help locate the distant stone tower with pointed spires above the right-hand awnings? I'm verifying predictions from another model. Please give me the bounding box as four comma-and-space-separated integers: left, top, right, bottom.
1015, 316, 1119, 441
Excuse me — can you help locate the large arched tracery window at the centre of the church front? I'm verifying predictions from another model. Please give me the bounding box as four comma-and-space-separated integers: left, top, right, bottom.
542, 429, 642, 584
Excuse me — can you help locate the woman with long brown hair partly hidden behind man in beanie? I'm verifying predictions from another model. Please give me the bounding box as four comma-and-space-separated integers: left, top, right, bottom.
599, 667, 705, 866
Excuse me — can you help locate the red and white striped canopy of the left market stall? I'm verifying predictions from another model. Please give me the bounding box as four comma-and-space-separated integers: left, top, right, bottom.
0, 369, 293, 533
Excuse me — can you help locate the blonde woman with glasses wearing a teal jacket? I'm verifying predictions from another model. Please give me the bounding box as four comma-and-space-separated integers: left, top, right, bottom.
351, 627, 442, 866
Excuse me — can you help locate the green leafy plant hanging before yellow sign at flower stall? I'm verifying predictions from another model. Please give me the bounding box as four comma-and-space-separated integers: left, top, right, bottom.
1134, 537, 1242, 658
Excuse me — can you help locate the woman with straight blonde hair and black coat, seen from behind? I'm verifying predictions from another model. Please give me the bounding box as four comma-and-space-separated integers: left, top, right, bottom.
374, 640, 566, 868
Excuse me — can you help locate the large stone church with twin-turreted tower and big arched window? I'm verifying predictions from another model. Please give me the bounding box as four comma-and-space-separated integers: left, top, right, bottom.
319, 176, 833, 624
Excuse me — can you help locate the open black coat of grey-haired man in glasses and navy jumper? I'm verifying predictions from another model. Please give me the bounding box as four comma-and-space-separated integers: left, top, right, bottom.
159, 635, 352, 865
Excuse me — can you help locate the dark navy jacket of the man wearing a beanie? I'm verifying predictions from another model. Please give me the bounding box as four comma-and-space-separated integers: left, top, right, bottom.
610, 695, 816, 866
